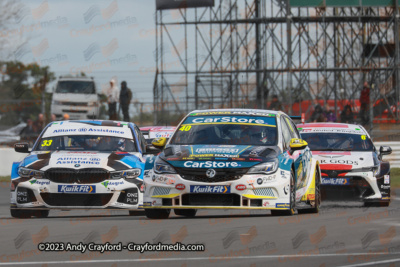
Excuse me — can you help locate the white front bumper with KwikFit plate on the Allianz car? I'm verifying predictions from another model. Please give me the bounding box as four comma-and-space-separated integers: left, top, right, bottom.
10, 179, 143, 210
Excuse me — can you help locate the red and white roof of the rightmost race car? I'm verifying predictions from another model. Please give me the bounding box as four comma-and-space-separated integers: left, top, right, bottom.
297, 122, 366, 134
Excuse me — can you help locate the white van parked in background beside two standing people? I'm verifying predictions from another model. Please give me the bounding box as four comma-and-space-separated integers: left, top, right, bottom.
51, 77, 100, 120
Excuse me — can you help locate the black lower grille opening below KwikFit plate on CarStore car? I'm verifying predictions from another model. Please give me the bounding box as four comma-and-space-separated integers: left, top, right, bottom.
182, 194, 240, 206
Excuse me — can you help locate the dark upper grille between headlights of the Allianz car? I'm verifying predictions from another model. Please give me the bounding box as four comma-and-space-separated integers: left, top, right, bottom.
45, 168, 109, 184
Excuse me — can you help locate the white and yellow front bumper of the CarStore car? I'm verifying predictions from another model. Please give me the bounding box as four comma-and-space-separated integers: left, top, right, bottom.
143, 169, 290, 210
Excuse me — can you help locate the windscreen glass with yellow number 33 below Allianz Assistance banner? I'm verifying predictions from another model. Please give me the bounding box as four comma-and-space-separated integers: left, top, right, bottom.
35, 135, 137, 152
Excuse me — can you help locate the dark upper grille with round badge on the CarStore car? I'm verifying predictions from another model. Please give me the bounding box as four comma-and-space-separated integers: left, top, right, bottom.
175, 168, 248, 183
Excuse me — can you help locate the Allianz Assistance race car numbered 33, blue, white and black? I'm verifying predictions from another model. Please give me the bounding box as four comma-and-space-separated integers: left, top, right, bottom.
10, 120, 151, 218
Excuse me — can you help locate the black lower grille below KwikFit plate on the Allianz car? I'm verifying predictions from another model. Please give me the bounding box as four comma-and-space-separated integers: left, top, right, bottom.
40, 193, 113, 207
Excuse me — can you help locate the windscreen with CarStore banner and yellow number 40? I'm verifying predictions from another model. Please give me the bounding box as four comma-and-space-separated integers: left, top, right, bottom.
170, 116, 277, 146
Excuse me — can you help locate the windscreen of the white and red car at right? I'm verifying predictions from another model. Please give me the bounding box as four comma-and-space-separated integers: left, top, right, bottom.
301, 132, 374, 151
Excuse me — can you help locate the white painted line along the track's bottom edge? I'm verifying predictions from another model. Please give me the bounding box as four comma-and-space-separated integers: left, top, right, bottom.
0, 252, 400, 267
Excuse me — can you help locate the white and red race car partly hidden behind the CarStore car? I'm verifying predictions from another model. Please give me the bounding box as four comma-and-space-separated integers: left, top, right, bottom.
297, 123, 392, 206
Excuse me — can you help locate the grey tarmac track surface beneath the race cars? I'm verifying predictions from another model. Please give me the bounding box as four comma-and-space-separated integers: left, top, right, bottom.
0, 186, 400, 267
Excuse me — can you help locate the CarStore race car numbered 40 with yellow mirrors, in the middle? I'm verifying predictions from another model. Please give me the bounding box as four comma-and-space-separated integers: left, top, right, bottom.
143, 109, 321, 219
